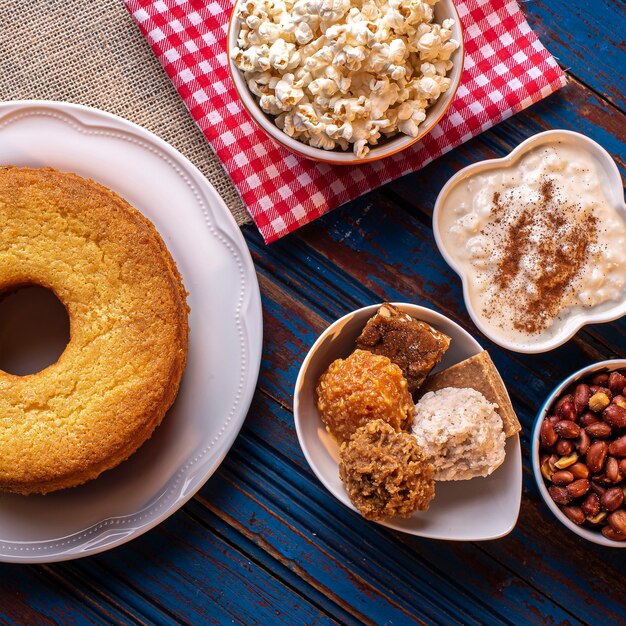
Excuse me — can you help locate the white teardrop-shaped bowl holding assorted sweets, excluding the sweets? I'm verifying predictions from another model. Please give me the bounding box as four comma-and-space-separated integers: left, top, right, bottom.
294, 303, 522, 541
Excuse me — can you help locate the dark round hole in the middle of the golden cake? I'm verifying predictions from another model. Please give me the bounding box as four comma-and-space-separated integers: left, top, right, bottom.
0, 285, 70, 376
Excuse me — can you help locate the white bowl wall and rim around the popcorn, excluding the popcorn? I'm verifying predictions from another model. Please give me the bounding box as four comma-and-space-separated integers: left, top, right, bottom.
228, 0, 465, 165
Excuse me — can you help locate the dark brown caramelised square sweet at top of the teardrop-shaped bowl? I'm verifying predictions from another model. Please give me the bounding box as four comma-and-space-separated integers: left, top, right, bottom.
356, 302, 450, 393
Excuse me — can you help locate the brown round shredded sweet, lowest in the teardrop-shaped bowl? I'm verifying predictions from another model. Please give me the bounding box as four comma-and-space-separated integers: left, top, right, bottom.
339, 419, 435, 520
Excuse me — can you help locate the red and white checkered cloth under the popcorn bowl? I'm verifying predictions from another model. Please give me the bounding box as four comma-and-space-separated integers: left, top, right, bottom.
124, 0, 565, 243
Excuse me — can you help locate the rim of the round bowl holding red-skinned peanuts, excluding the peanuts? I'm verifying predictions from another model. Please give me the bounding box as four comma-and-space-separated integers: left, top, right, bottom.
530, 359, 626, 548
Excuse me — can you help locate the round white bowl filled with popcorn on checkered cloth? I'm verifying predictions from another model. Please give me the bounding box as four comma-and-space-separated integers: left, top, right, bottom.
228, 0, 464, 164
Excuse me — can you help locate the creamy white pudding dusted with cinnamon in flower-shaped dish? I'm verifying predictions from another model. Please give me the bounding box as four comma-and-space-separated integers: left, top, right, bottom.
438, 142, 626, 346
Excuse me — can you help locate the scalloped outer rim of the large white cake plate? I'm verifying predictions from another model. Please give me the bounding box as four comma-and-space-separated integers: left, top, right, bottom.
0, 100, 263, 563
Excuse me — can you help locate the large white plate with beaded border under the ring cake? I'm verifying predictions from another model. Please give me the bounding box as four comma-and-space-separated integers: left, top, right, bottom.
0, 101, 262, 562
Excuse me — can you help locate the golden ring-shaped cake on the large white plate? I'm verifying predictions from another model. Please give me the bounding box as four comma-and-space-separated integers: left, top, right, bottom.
0, 167, 189, 494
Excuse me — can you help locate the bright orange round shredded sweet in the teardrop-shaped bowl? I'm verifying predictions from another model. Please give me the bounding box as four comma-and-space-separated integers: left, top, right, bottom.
317, 350, 414, 443
